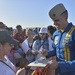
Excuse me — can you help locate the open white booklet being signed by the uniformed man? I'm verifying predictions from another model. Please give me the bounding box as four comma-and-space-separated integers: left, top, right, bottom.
28, 57, 50, 67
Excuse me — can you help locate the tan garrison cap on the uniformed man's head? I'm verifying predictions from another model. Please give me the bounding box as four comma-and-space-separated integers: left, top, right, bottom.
49, 3, 66, 19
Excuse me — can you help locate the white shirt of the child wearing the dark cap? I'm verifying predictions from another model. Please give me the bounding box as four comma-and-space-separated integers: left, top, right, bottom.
0, 56, 16, 75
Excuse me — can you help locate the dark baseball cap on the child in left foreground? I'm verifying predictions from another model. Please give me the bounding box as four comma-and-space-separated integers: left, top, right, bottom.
0, 31, 19, 46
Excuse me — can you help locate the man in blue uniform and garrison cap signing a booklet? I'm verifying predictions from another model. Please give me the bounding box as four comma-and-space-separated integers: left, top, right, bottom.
43, 3, 75, 75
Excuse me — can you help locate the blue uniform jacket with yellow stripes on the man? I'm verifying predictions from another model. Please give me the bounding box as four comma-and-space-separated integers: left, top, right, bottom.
49, 23, 75, 75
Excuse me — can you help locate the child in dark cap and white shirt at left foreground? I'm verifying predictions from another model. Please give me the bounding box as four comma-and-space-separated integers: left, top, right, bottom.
0, 30, 25, 75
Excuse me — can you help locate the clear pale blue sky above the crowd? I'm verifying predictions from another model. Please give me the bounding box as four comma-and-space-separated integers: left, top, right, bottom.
0, 0, 75, 28
